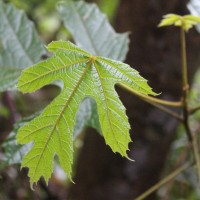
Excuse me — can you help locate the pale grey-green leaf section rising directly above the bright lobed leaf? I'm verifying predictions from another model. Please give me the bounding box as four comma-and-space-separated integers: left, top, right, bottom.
58, 0, 129, 61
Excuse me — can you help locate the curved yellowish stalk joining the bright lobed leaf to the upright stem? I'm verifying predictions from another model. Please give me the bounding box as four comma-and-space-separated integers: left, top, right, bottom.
119, 83, 183, 107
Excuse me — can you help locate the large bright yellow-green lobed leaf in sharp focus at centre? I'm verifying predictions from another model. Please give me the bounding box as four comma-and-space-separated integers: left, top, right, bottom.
17, 41, 154, 185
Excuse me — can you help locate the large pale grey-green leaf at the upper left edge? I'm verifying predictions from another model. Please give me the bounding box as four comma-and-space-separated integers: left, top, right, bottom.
0, 1, 45, 91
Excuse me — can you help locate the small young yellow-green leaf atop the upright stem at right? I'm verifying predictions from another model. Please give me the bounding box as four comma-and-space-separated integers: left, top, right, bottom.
158, 14, 200, 31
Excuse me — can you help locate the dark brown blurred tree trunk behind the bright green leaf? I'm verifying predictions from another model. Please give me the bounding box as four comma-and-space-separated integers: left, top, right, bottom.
69, 0, 200, 200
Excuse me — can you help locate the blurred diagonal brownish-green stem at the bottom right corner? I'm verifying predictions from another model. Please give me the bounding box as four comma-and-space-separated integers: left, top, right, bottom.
135, 163, 191, 200
